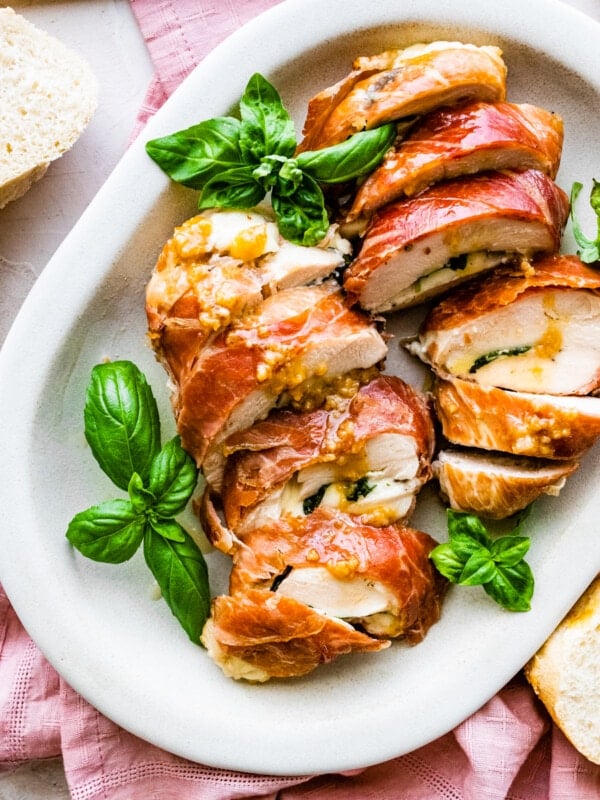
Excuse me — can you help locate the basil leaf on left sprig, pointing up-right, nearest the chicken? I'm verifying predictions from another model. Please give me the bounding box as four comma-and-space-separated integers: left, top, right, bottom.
148, 436, 198, 517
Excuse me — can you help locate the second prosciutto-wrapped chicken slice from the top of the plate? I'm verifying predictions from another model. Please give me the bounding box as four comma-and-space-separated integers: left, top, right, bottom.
348, 102, 563, 225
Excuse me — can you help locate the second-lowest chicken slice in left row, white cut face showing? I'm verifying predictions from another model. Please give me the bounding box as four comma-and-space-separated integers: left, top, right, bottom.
230, 508, 446, 644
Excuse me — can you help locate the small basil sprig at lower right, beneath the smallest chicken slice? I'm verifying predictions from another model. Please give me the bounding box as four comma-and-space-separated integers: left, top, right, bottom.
430, 509, 534, 611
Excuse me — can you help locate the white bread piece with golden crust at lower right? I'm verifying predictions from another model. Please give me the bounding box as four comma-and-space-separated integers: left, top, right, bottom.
525, 575, 600, 764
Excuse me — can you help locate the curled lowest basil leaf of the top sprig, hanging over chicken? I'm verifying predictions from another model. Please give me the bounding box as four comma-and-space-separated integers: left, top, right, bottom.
271, 175, 329, 246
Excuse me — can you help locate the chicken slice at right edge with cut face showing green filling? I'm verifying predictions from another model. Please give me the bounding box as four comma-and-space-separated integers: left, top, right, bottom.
408, 255, 600, 395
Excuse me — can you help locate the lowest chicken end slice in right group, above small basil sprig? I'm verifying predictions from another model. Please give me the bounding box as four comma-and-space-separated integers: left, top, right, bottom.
433, 449, 579, 519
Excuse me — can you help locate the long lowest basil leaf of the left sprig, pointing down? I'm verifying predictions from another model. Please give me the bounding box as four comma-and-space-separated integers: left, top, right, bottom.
144, 526, 210, 644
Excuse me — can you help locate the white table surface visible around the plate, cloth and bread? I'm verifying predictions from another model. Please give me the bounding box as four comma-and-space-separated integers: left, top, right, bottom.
0, 0, 600, 800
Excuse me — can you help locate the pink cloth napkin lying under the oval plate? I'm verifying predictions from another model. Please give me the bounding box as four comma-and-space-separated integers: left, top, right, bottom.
0, 0, 600, 800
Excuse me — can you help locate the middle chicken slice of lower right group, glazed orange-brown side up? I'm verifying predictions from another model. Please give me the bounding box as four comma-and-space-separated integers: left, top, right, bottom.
434, 378, 600, 459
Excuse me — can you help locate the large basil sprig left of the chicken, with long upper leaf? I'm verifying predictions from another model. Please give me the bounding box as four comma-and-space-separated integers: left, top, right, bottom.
66, 361, 210, 644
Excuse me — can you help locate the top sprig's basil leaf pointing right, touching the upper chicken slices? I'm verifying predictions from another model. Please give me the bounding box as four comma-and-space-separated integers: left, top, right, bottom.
297, 123, 396, 183
